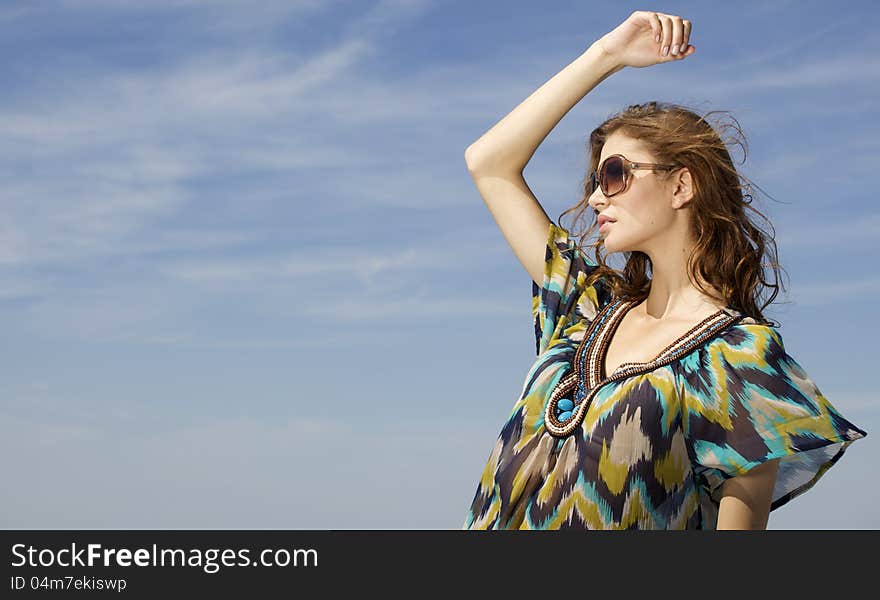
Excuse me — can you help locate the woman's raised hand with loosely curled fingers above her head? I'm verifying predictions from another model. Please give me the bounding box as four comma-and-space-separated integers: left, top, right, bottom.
598, 10, 697, 67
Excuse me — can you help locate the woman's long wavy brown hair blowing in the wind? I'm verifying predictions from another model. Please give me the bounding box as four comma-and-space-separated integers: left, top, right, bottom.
557, 102, 785, 327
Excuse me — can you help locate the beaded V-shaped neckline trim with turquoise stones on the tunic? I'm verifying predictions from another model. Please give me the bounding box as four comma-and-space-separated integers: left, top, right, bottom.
544, 299, 754, 437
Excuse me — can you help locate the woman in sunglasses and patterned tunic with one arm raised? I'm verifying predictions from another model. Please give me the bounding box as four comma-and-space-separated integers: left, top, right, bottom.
463, 11, 867, 529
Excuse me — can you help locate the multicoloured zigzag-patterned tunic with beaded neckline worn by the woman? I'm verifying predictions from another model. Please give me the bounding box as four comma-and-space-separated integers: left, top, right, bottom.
462, 223, 867, 529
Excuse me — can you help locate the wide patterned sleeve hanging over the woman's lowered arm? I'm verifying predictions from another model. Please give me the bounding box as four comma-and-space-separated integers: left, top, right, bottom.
680, 324, 867, 519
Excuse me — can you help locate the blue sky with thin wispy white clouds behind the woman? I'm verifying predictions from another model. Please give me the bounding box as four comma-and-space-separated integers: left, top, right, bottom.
0, 0, 880, 529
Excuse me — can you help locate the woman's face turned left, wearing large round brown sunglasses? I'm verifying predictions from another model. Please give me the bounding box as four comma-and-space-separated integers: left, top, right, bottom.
588, 132, 676, 254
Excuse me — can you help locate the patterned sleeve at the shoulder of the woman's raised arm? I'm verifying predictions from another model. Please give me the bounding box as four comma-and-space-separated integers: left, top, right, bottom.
532, 222, 611, 354
